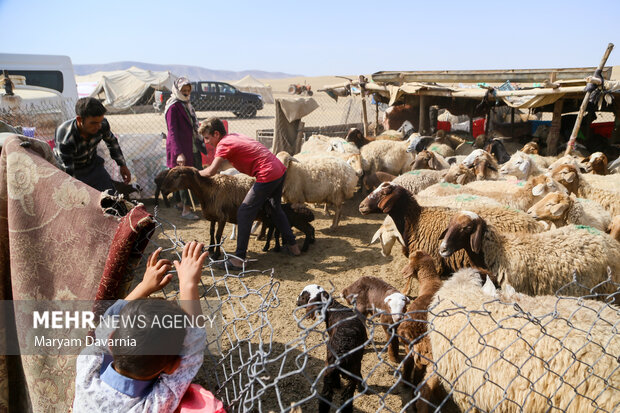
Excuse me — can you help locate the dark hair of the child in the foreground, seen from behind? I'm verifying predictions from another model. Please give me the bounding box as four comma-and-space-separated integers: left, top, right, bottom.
109, 299, 189, 377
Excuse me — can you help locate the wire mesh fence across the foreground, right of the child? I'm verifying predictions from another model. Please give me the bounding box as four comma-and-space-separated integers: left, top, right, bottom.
122, 210, 620, 412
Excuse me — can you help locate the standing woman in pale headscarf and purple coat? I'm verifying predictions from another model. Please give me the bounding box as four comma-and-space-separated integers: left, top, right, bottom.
164, 77, 206, 220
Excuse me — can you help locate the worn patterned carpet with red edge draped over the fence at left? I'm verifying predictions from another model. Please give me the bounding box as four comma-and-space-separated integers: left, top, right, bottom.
0, 135, 154, 412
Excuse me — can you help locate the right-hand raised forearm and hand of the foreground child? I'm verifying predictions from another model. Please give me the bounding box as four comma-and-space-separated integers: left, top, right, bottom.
174, 241, 209, 316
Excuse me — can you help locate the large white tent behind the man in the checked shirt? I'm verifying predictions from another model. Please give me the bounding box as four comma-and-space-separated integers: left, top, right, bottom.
76, 66, 177, 112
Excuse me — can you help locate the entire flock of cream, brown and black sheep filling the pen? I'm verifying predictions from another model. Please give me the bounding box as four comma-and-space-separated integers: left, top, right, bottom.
153, 125, 620, 412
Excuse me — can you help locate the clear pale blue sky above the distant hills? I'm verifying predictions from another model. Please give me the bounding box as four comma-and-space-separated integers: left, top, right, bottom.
0, 0, 620, 76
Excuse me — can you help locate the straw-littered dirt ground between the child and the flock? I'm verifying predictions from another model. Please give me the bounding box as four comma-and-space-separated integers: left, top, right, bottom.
138, 188, 417, 412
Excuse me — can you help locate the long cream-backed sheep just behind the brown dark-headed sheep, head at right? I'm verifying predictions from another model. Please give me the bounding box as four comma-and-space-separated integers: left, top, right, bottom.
418, 175, 566, 211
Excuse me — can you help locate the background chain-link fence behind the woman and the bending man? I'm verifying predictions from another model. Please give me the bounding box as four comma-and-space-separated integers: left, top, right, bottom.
0, 93, 377, 198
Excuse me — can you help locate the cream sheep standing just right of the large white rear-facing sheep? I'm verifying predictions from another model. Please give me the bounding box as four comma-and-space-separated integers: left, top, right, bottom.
361, 140, 413, 175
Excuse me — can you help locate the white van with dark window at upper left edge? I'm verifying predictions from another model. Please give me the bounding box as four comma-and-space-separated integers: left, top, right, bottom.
0, 53, 78, 102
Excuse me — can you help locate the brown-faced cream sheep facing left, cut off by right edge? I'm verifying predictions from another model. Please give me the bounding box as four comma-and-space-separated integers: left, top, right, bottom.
551, 165, 620, 215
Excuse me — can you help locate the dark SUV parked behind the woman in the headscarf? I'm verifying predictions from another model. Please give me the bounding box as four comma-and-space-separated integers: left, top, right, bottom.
153, 81, 263, 118
